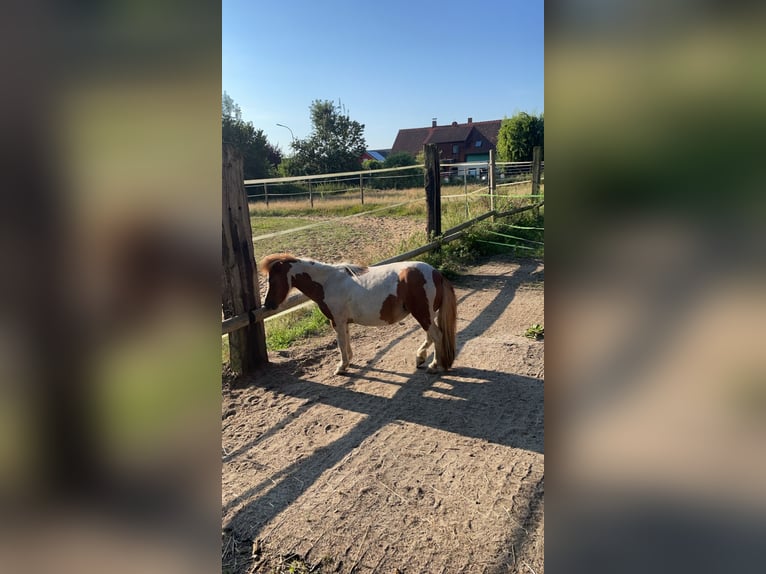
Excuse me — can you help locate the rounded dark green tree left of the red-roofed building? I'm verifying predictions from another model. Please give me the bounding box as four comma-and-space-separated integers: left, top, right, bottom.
285, 100, 367, 175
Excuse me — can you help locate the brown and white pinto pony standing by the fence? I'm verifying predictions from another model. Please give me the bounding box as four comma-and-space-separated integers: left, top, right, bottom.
260, 253, 457, 374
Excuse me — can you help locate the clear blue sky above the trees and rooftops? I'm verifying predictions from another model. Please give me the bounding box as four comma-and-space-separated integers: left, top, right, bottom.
222, 0, 544, 154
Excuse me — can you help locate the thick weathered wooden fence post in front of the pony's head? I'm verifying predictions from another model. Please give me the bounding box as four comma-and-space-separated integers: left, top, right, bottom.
222, 144, 269, 375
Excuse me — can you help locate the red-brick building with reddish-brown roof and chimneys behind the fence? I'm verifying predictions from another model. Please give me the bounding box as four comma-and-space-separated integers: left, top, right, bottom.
391, 118, 503, 167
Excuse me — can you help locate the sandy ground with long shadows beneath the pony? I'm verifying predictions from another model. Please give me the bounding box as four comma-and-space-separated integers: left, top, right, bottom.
222, 257, 544, 574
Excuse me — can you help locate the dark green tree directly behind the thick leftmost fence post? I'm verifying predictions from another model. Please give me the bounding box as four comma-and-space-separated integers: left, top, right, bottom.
221, 92, 282, 179
